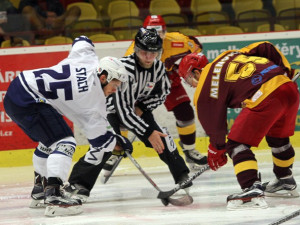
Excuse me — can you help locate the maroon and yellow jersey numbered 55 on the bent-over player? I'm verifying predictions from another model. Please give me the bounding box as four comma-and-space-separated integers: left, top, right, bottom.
194, 42, 291, 149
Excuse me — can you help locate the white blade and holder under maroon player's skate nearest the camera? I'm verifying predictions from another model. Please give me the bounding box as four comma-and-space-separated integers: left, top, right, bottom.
227, 197, 268, 210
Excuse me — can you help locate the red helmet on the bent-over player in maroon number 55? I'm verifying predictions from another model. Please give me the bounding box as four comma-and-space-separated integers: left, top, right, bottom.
178, 52, 209, 86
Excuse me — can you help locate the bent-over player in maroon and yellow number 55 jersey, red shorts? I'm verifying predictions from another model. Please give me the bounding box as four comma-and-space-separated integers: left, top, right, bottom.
179, 42, 299, 209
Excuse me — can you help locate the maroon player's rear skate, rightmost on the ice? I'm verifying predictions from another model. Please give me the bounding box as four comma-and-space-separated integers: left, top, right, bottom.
263, 175, 299, 198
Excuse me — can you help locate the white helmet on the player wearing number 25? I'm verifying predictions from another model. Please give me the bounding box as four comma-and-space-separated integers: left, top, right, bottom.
97, 56, 127, 83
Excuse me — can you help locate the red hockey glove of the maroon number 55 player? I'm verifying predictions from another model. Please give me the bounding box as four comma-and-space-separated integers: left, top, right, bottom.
207, 144, 227, 171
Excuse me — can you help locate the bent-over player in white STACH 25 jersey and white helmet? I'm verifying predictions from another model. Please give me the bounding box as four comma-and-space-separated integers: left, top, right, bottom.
4, 36, 132, 216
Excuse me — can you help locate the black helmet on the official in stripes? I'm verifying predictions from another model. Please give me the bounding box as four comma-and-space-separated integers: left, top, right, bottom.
135, 28, 162, 52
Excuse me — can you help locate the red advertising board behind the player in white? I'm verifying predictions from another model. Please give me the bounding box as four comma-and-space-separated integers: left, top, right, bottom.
0, 51, 73, 151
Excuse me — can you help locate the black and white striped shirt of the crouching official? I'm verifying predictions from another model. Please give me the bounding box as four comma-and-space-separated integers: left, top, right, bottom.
107, 53, 171, 137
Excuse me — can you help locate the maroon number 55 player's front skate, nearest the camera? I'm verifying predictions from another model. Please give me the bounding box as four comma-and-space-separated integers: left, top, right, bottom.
227, 181, 268, 210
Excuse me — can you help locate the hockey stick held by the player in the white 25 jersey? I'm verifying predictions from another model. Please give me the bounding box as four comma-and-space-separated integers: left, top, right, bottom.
125, 151, 193, 206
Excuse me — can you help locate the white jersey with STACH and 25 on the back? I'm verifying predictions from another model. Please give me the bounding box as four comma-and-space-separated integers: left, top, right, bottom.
7, 36, 116, 150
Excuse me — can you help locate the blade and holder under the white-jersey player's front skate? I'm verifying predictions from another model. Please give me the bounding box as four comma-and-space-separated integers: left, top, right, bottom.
44, 205, 83, 217
